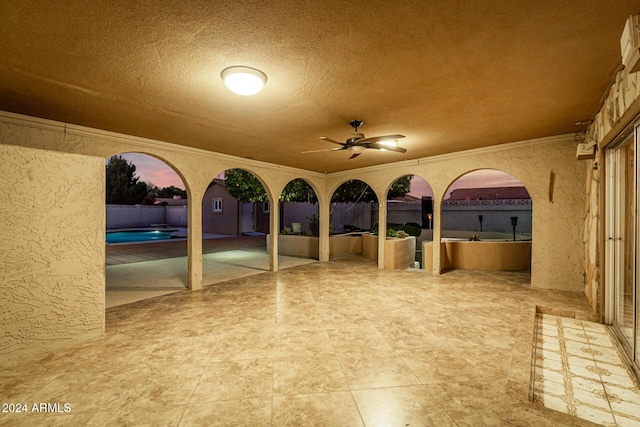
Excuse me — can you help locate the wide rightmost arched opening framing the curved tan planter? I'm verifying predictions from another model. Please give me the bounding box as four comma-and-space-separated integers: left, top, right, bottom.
441, 169, 533, 271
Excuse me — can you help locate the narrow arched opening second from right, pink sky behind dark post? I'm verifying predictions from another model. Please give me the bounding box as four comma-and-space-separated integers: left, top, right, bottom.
382, 175, 433, 268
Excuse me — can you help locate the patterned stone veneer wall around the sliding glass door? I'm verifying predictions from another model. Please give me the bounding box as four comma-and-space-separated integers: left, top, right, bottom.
583, 69, 640, 315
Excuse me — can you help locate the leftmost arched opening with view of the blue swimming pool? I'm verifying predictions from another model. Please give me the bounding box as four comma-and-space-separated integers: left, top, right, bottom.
105, 153, 188, 308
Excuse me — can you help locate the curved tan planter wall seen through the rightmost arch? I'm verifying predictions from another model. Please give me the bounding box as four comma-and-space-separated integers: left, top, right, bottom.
422, 240, 531, 271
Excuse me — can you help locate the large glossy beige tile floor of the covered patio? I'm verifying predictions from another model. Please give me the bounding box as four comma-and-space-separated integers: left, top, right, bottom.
0, 256, 608, 427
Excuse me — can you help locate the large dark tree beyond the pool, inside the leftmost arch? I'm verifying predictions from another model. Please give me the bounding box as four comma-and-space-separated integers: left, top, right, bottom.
105, 156, 154, 205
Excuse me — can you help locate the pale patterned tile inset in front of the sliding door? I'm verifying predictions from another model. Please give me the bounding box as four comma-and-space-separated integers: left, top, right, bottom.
534, 313, 640, 426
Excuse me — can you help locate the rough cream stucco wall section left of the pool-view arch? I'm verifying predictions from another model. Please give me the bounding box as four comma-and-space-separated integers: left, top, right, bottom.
0, 144, 105, 359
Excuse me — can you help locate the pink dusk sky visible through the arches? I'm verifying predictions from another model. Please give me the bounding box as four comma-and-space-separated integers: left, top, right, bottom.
122, 153, 522, 198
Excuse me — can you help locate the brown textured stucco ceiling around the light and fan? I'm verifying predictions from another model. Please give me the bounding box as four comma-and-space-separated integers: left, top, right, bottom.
0, 0, 640, 172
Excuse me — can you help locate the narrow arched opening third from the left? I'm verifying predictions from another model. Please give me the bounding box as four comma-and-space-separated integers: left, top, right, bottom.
278, 178, 320, 267
